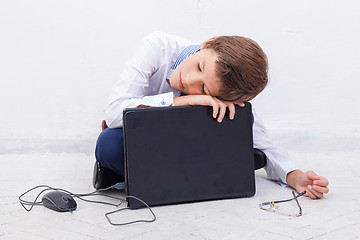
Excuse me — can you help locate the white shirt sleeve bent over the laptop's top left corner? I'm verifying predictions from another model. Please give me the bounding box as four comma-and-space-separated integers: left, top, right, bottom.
105, 32, 173, 128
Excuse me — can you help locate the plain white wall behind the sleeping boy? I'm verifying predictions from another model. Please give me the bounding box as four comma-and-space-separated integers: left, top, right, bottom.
0, 0, 360, 154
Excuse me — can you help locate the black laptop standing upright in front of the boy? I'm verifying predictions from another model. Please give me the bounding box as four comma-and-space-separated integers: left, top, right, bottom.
124, 103, 255, 208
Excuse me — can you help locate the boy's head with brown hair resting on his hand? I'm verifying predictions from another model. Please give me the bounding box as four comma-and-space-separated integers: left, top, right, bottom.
170, 36, 268, 102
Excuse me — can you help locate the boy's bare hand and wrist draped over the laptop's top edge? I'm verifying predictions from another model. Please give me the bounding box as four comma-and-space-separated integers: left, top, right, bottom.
174, 95, 245, 123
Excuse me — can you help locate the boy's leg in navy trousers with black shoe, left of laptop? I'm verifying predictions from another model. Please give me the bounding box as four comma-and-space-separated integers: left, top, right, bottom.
93, 128, 124, 189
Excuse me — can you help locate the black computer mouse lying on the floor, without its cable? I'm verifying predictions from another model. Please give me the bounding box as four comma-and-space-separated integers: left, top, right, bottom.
41, 190, 77, 212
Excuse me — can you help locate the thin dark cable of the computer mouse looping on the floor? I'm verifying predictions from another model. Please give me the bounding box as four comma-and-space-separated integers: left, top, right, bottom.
19, 184, 156, 226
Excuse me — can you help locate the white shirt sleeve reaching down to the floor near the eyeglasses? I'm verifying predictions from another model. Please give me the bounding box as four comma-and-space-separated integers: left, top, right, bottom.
253, 106, 298, 184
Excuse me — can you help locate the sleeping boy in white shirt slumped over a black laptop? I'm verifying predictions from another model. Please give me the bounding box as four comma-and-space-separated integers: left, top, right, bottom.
94, 32, 329, 199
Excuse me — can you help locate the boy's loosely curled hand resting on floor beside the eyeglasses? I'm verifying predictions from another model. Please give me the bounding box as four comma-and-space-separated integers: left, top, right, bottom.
286, 170, 329, 199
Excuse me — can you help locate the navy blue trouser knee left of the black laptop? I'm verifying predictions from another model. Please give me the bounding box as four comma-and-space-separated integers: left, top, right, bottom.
95, 124, 124, 176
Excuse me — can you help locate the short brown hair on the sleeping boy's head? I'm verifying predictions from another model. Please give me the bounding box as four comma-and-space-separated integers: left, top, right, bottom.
205, 36, 268, 102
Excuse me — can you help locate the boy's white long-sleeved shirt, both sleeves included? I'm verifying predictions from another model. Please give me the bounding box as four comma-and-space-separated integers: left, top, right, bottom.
105, 32, 297, 183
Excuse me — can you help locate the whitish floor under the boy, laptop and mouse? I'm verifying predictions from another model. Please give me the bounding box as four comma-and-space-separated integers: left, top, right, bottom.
0, 142, 360, 240
